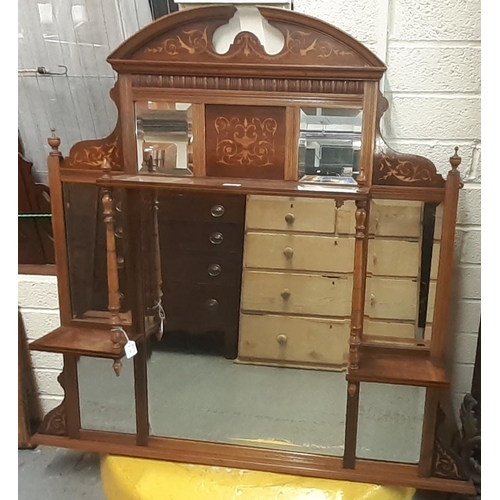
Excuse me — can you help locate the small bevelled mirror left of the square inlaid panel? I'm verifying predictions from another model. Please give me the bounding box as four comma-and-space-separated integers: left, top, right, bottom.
135, 101, 193, 176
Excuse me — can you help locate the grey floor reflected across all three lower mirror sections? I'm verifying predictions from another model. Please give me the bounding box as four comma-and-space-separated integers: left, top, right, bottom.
80, 350, 425, 463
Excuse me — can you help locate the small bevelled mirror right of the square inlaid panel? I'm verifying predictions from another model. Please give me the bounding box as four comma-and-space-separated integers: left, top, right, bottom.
299, 108, 362, 182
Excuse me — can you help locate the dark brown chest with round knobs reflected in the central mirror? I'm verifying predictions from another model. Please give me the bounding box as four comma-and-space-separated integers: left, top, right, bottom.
159, 189, 245, 359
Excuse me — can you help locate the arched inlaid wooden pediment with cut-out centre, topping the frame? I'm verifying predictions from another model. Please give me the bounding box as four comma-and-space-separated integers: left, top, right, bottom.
108, 6, 385, 79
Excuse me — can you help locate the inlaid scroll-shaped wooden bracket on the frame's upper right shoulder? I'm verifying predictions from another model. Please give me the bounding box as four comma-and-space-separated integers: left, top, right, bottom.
373, 94, 445, 188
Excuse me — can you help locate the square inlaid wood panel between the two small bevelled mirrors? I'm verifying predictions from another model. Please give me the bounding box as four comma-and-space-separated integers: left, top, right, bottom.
205, 105, 286, 179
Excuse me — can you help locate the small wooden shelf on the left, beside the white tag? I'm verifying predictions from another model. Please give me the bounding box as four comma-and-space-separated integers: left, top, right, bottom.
29, 326, 132, 359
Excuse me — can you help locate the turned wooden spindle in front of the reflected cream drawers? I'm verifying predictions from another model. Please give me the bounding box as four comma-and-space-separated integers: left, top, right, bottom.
349, 200, 367, 370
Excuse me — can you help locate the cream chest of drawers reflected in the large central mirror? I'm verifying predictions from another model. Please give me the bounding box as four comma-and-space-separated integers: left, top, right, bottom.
238, 196, 355, 370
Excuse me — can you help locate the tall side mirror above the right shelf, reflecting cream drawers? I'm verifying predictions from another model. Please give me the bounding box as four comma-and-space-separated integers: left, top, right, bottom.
364, 200, 442, 345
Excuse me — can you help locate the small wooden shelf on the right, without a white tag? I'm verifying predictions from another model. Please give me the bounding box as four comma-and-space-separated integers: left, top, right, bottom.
347, 350, 450, 388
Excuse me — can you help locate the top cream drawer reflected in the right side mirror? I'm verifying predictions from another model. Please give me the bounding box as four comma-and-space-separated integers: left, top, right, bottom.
370, 200, 422, 239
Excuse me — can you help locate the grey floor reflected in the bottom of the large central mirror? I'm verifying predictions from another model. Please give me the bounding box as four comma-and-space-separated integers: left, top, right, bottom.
148, 337, 347, 456
